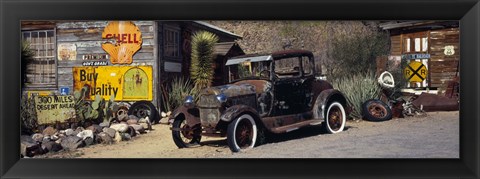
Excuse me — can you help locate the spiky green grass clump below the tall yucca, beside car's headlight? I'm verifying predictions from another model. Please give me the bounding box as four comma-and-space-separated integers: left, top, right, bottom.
162, 77, 198, 111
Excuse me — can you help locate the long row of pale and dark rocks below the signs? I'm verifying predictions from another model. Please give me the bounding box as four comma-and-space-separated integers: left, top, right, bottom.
20, 115, 152, 157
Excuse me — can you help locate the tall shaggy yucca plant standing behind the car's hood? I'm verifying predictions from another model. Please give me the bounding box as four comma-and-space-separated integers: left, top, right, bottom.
190, 31, 218, 90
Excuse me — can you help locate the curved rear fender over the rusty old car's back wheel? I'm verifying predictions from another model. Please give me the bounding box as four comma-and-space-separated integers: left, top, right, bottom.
313, 89, 347, 119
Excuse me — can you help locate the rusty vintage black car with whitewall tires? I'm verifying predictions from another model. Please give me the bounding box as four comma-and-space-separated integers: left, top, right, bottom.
169, 50, 347, 152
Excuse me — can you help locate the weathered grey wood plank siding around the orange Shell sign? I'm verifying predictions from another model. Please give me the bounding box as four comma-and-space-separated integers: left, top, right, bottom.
56, 21, 158, 105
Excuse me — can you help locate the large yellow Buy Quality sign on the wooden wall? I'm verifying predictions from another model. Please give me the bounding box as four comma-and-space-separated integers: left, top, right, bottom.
73, 66, 153, 101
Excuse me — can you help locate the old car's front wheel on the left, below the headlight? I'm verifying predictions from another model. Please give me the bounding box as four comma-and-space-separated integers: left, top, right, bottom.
172, 118, 202, 148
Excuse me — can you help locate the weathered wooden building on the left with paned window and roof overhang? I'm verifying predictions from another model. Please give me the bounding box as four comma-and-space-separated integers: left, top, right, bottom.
21, 21, 243, 111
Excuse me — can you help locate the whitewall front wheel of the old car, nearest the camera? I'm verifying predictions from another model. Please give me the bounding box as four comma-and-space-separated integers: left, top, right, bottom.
227, 114, 257, 152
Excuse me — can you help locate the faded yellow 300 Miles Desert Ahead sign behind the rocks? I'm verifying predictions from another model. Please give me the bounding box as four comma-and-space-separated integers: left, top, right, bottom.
35, 95, 75, 124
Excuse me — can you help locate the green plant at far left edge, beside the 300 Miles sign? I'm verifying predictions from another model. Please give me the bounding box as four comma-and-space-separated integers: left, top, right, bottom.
20, 94, 38, 130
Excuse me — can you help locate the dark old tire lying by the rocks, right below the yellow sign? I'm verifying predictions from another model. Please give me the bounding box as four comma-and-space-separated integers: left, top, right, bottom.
128, 101, 159, 123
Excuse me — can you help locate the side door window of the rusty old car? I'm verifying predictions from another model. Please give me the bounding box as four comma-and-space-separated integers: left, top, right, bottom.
274, 57, 301, 78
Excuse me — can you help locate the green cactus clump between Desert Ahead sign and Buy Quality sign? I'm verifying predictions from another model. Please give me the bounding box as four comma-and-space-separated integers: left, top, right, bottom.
74, 87, 118, 122
